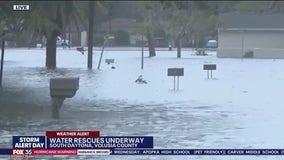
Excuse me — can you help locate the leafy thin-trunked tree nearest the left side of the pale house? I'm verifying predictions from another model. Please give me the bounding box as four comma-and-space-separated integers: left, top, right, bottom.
162, 1, 218, 58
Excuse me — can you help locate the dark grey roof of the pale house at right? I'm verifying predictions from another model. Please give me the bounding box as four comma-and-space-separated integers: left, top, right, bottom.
219, 13, 284, 29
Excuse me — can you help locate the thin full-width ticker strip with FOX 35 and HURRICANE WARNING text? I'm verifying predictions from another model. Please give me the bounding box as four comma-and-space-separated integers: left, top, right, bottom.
0, 148, 284, 158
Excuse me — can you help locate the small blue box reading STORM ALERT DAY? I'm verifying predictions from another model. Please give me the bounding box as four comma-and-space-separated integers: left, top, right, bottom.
13, 136, 45, 148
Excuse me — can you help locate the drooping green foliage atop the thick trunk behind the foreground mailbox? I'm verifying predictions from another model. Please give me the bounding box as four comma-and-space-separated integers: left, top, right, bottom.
24, 1, 78, 37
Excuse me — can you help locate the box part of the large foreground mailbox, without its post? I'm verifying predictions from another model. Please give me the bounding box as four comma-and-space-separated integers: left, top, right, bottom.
49, 77, 79, 98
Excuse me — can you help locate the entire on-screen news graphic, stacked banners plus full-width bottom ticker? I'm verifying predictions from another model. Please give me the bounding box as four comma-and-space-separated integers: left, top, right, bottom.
0, 131, 284, 158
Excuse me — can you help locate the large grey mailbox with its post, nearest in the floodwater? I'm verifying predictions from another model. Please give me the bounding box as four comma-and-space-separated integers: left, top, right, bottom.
49, 77, 79, 118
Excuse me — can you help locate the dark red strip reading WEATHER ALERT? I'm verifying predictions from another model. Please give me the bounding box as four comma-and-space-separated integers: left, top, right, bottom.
46, 131, 100, 138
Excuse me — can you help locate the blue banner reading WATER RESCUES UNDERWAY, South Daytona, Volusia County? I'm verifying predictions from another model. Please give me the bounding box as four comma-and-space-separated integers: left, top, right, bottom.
47, 136, 154, 149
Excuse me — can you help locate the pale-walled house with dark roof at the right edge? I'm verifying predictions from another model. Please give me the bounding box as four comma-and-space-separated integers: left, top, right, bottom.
217, 13, 284, 59
